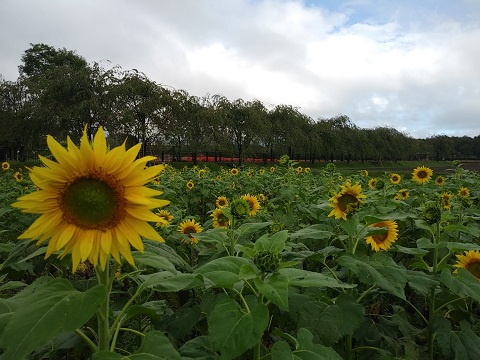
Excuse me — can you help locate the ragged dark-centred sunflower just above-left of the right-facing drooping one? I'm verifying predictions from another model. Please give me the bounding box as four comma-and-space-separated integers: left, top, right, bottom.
328, 181, 366, 220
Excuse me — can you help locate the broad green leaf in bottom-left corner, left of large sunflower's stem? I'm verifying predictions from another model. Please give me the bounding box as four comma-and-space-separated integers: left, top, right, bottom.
0, 277, 107, 360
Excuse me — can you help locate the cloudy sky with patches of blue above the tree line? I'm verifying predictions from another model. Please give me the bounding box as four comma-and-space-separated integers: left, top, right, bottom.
0, 0, 480, 138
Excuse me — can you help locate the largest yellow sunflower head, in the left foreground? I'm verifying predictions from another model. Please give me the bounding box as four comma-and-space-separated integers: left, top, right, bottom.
12, 127, 169, 271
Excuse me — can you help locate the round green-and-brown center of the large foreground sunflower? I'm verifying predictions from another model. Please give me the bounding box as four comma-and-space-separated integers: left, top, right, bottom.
61, 177, 125, 229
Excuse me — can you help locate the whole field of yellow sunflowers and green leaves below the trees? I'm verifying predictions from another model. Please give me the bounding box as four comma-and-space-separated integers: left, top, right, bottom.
0, 128, 480, 360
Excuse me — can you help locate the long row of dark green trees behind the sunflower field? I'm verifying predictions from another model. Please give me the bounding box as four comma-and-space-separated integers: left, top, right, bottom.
0, 44, 480, 165
